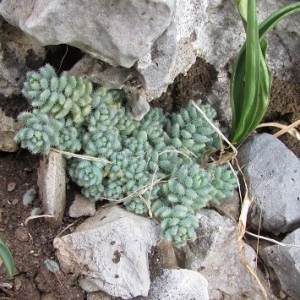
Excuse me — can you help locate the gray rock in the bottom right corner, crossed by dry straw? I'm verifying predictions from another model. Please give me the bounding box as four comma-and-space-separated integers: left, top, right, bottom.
263, 228, 300, 299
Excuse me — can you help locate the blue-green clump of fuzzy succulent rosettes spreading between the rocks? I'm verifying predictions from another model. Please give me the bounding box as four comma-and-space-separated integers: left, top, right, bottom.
15, 65, 236, 247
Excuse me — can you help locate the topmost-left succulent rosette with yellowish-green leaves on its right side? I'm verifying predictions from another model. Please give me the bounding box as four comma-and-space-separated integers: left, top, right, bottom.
22, 64, 93, 123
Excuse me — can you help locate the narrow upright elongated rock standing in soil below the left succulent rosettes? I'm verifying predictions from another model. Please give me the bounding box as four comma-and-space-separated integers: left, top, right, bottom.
38, 151, 66, 227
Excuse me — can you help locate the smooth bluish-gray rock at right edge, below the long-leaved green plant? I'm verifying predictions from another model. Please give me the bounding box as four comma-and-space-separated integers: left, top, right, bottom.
238, 133, 300, 233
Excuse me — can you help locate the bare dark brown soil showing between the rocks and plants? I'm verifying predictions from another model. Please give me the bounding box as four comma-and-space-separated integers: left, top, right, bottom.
0, 51, 300, 300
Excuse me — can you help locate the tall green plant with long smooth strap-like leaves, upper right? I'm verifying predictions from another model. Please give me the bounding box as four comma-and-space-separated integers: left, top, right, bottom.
230, 0, 300, 144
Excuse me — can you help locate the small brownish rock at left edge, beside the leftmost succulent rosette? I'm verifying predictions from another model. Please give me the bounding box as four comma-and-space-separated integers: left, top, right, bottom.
0, 108, 21, 152
